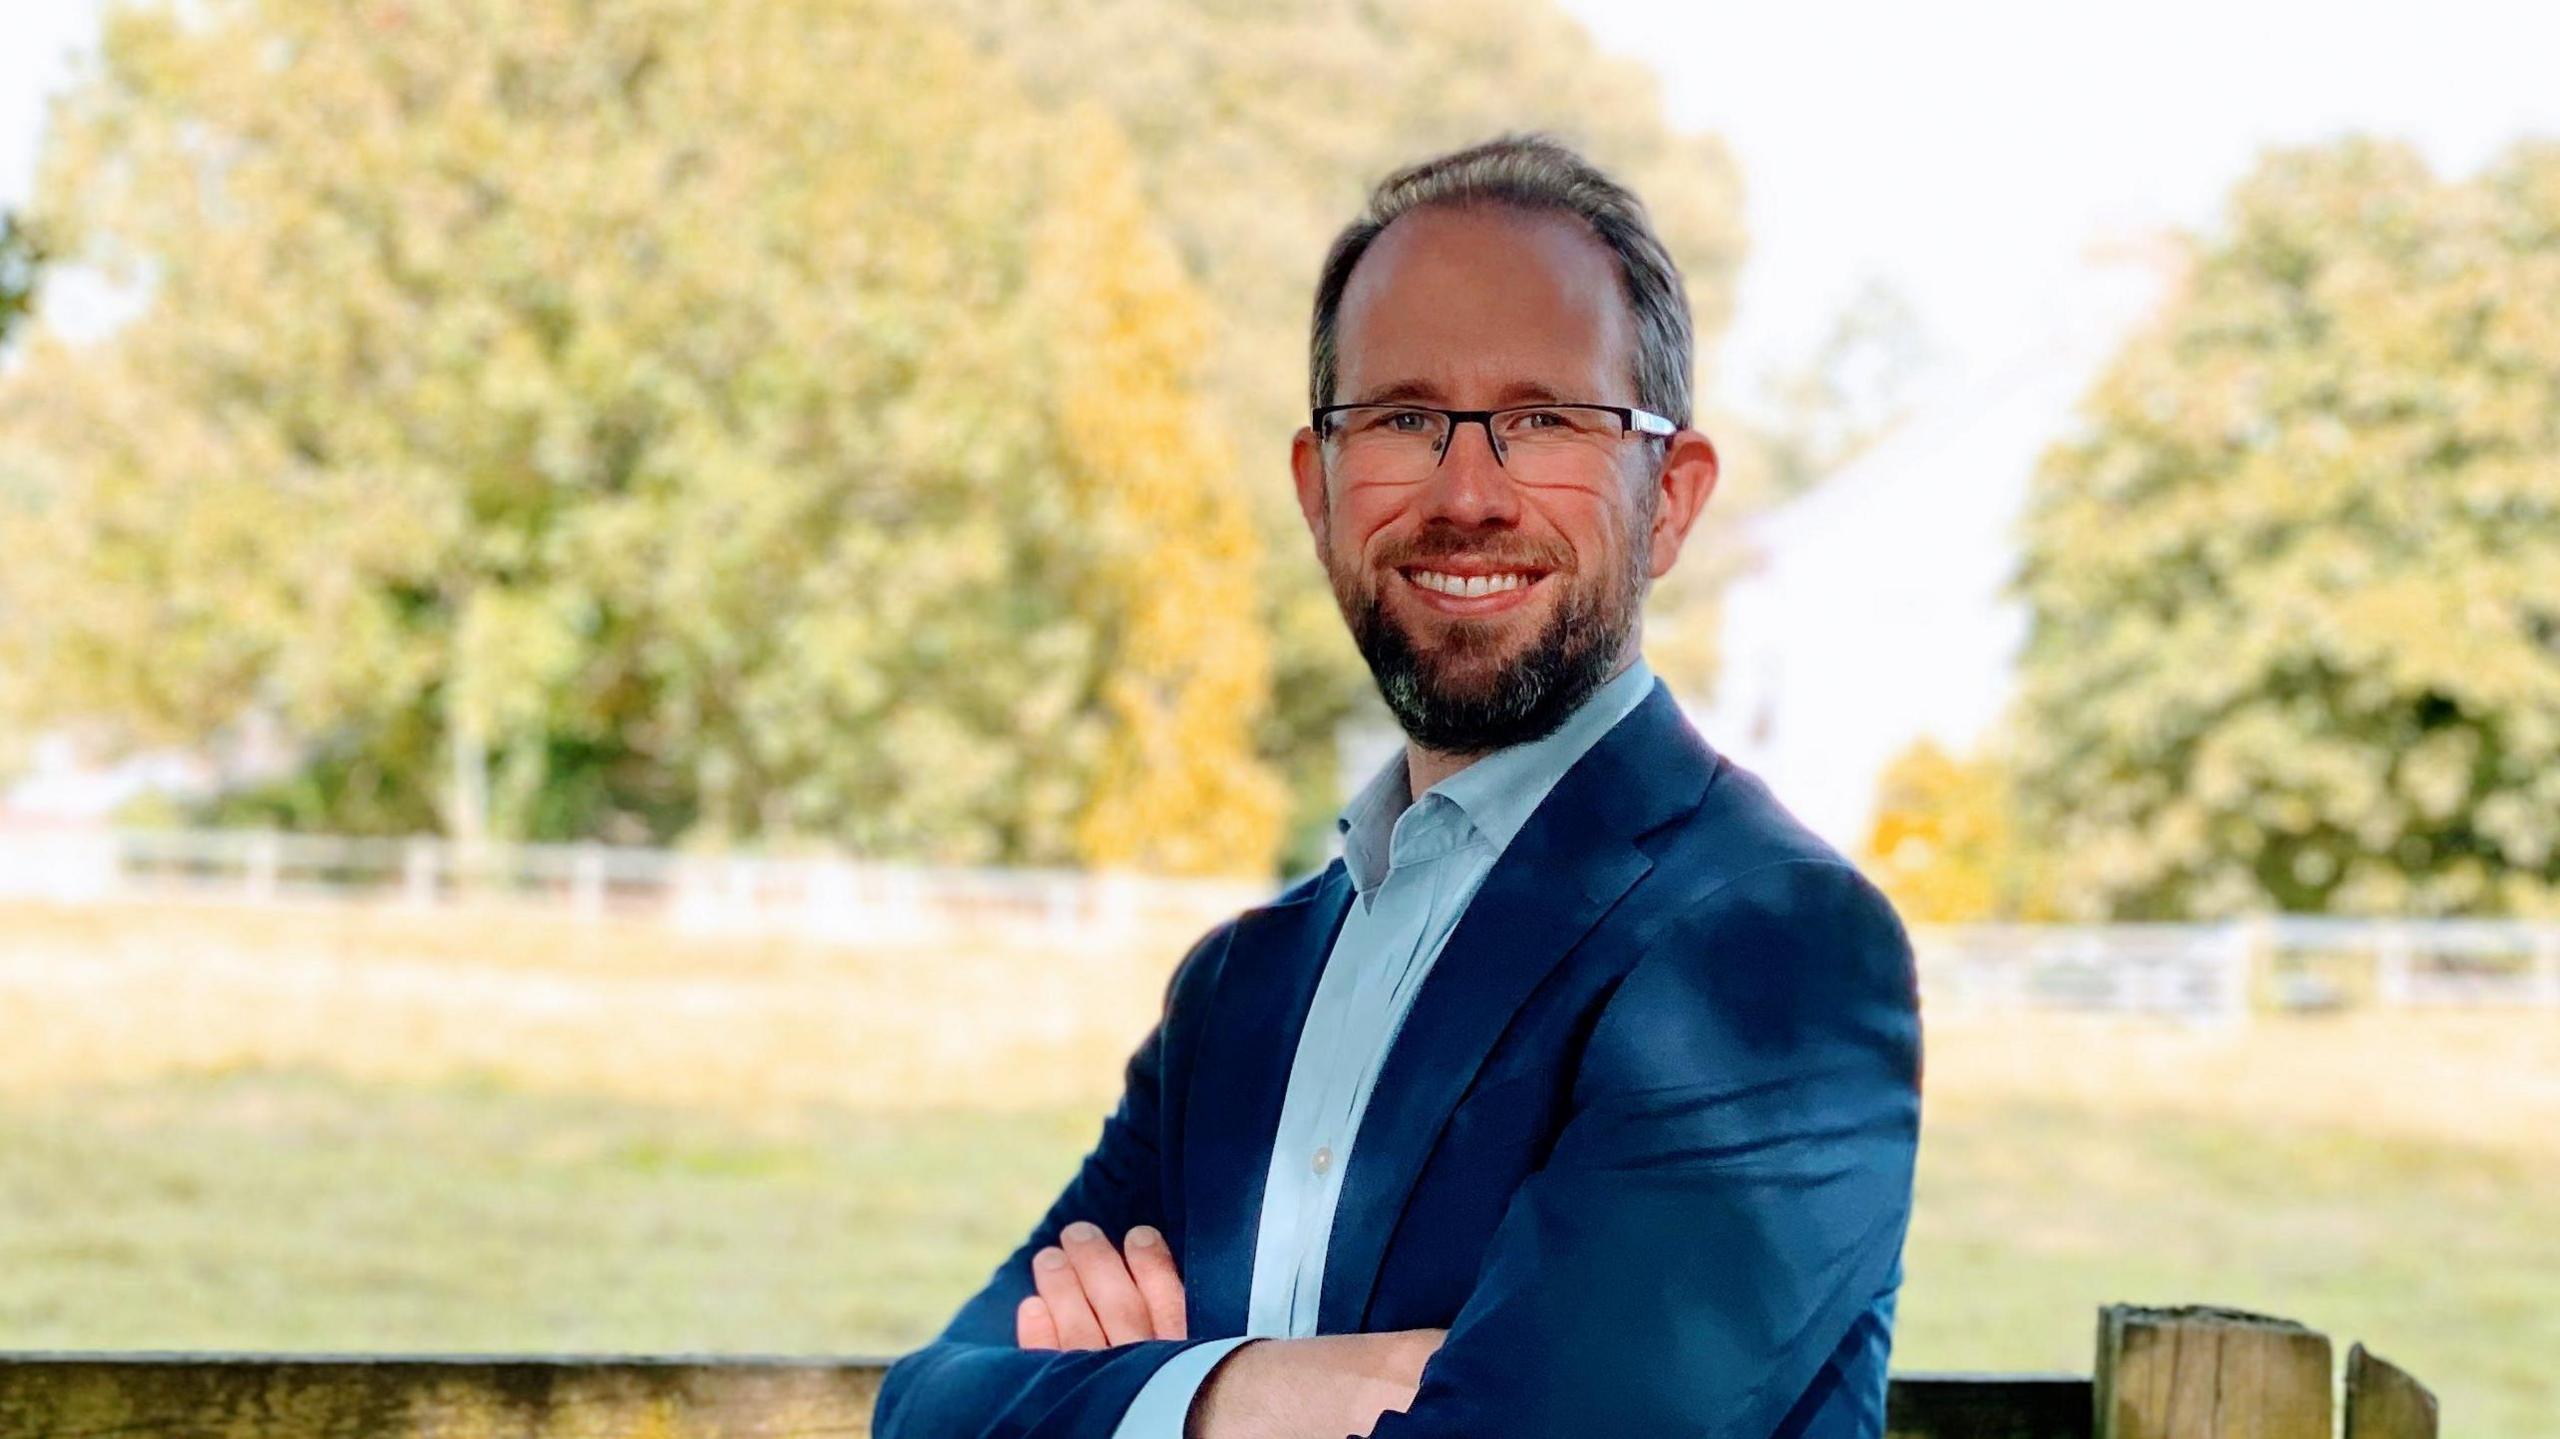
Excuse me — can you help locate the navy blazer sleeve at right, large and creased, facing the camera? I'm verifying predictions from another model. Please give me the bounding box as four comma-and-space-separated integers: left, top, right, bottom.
1370, 858, 1920, 1439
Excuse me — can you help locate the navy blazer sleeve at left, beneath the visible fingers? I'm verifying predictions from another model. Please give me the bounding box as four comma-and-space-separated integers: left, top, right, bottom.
870, 924, 1229, 1439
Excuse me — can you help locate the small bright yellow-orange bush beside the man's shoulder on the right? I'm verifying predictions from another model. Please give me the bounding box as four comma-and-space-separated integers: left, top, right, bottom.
1866, 740, 2056, 924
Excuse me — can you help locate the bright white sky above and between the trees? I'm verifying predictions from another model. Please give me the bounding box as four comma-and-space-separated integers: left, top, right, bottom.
0, 0, 2560, 399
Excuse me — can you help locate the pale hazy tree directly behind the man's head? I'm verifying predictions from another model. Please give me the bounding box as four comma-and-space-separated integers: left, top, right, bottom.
945, 0, 1759, 865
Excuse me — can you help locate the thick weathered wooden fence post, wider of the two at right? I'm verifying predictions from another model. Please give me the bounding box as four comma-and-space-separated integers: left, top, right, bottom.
2092, 1303, 2332, 1439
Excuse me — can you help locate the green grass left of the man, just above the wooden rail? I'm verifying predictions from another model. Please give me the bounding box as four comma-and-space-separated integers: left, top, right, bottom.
0, 1073, 1098, 1352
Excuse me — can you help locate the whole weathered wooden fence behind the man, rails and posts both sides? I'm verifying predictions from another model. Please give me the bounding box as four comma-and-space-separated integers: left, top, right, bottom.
0, 1306, 2437, 1439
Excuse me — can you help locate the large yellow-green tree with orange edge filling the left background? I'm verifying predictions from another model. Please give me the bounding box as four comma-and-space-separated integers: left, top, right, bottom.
0, 0, 1275, 871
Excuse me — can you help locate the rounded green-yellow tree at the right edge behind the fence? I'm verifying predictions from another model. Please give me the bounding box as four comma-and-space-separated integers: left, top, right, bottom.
2020, 141, 2560, 919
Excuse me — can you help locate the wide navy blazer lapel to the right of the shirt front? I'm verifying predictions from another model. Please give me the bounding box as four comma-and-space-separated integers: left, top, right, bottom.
1320, 684, 1715, 1334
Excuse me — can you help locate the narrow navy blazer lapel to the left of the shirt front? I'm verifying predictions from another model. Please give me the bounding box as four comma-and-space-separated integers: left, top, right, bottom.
1183, 860, 1352, 1334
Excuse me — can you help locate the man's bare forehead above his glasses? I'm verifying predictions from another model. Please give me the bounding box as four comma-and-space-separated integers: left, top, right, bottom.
1336, 205, 1633, 402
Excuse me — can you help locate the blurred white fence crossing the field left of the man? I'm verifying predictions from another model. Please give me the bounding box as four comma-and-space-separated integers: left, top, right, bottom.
0, 830, 1272, 945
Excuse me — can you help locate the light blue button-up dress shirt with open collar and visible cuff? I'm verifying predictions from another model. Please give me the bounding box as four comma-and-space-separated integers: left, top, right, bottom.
1114, 658, 1654, 1439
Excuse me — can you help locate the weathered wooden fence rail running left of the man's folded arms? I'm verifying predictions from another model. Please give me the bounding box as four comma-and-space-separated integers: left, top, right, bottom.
0, 1355, 883, 1439
